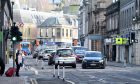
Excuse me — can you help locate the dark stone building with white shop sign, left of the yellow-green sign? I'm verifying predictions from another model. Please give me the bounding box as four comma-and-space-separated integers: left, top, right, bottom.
104, 1, 120, 62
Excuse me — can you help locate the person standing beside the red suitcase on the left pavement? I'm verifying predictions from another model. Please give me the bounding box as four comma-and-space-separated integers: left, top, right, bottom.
15, 50, 23, 77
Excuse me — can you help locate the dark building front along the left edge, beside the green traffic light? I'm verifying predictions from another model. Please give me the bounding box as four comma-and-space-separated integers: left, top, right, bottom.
0, 0, 12, 63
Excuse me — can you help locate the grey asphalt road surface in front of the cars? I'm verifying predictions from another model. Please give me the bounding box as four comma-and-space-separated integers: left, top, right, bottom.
23, 57, 140, 84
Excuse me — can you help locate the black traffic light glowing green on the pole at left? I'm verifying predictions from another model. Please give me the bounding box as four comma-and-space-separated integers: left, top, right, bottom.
10, 25, 22, 42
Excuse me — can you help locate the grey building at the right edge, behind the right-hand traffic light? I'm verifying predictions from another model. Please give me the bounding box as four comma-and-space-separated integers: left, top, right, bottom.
120, 0, 140, 65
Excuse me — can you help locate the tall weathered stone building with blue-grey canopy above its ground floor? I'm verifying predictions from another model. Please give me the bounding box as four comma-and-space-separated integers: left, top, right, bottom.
80, 0, 112, 52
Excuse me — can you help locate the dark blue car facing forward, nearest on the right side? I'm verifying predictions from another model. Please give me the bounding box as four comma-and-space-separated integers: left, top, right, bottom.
82, 51, 106, 69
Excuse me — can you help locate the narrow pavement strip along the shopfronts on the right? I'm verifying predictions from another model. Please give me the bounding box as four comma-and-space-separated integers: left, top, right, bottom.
107, 61, 140, 67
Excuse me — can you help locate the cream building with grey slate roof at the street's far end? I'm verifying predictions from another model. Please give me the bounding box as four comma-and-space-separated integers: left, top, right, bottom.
40, 14, 78, 47
